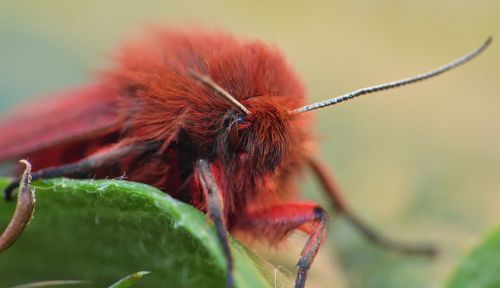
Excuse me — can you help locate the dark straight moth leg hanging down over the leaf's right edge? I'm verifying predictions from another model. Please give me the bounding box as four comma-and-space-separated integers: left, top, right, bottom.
197, 159, 234, 288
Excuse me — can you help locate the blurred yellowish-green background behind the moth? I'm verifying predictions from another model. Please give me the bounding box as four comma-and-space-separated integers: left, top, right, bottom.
0, 0, 500, 287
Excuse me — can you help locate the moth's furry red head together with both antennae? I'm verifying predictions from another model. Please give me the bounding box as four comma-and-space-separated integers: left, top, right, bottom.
190, 37, 492, 172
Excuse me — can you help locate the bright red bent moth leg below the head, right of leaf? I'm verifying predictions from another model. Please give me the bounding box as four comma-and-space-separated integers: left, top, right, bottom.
236, 203, 330, 288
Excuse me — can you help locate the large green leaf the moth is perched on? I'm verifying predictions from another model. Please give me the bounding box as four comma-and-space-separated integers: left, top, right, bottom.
0, 179, 290, 288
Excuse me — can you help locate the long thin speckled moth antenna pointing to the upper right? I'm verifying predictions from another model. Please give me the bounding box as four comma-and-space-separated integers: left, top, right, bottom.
290, 36, 493, 114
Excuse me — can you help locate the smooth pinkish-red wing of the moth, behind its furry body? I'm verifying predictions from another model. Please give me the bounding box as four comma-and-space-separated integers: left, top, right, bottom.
0, 85, 121, 160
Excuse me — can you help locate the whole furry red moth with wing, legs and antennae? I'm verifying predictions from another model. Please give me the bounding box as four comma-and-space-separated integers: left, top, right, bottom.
0, 30, 491, 288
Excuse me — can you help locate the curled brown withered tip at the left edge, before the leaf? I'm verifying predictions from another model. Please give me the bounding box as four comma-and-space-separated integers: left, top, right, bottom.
0, 160, 35, 253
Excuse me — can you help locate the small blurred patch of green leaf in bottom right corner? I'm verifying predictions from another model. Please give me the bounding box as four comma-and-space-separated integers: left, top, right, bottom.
448, 229, 500, 288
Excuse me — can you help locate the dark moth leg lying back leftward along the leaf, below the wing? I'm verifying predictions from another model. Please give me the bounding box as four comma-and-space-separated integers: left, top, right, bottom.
4, 143, 158, 200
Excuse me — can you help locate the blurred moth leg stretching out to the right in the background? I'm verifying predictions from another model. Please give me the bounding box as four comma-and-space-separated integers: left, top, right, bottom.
309, 158, 437, 256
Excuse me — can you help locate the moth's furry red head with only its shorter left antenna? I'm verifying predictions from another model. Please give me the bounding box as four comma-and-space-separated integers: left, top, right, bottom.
191, 71, 296, 173
